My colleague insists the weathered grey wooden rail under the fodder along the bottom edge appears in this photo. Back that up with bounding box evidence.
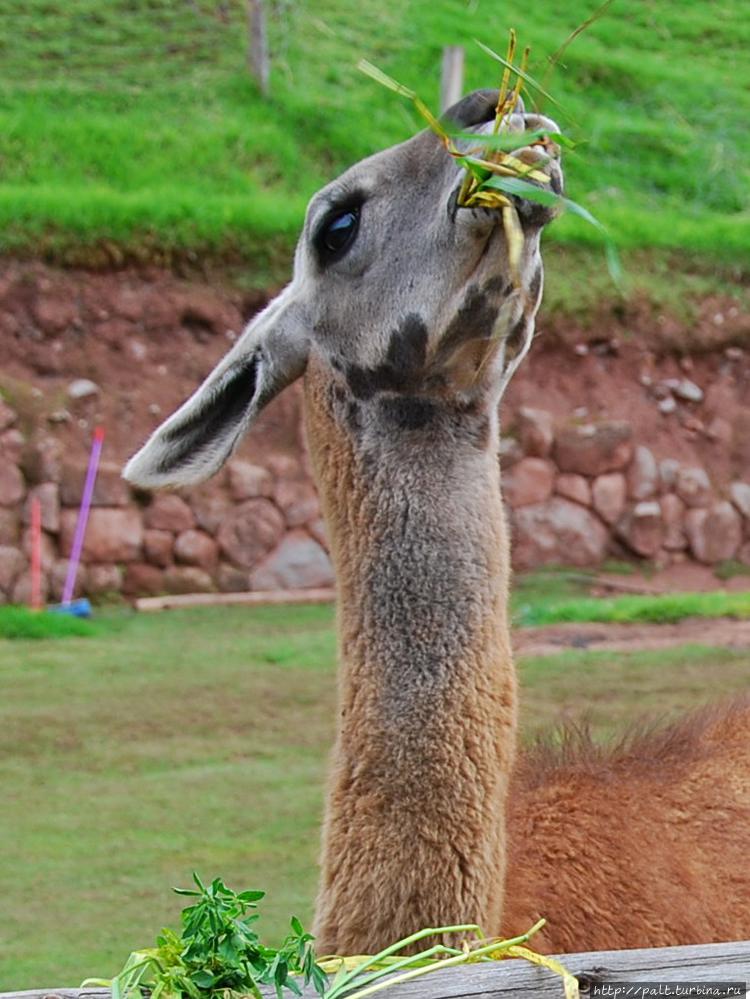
[8,940,750,999]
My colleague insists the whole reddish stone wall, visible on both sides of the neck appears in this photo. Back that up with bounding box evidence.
[0,402,750,603]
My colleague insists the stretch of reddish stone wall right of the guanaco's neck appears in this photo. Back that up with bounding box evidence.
[501,407,750,569]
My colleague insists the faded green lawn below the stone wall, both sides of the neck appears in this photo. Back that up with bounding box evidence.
[0,607,750,990]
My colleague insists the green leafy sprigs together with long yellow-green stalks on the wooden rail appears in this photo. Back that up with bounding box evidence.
[81,873,578,999]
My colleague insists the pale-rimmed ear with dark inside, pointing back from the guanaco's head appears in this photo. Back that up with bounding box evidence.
[123,285,308,489]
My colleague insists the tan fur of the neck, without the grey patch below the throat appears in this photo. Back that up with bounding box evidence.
[306,360,515,953]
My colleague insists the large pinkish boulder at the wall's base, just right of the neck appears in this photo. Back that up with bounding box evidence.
[511,496,607,569]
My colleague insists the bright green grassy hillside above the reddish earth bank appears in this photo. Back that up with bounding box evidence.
[0,0,750,276]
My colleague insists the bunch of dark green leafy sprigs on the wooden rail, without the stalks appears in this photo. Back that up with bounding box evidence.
[93,872,327,999]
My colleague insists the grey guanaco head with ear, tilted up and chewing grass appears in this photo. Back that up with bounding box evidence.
[124,91,562,487]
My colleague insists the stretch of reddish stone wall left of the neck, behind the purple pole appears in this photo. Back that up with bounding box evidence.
[0,402,333,603]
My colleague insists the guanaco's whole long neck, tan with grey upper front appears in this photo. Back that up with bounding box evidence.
[306,365,516,954]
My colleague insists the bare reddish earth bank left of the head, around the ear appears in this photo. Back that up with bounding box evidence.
[0,260,300,470]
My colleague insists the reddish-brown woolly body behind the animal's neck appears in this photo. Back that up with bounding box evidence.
[502,698,750,952]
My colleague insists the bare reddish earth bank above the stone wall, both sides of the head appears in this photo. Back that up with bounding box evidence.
[0,260,750,482]
